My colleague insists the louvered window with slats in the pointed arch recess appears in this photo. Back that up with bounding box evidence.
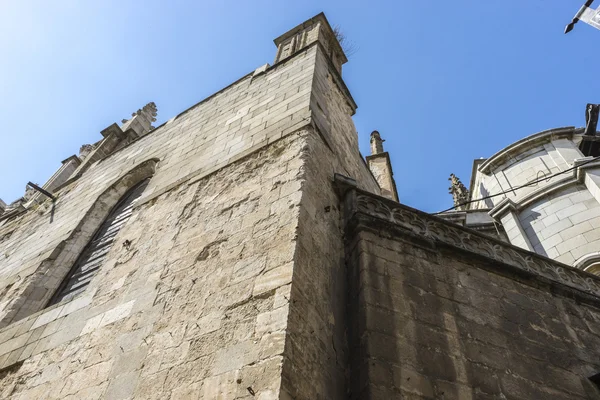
[48,179,150,306]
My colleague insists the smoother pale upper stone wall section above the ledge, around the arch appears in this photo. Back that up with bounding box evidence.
[0,46,316,327]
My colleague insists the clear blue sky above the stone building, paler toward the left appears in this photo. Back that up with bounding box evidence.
[0,0,600,212]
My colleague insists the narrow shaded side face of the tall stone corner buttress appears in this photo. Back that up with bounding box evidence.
[282,44,379,399]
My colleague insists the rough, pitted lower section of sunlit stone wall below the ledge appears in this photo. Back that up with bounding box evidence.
[0,132,306,399]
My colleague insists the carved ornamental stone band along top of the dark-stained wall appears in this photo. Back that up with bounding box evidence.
[346,190,600,296]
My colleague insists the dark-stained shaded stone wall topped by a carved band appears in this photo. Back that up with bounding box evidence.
[346,189,600,400]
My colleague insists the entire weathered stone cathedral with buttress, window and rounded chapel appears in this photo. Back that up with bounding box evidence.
[0,14,600,400]
